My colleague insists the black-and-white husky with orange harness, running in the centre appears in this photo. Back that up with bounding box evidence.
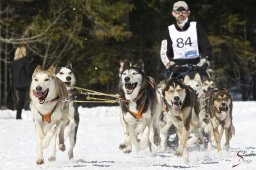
[119,60,161,153]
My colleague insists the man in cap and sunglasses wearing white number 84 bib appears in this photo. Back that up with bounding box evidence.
[160,1,212,79]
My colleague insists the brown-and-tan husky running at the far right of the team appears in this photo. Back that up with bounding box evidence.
[206,88,235,151]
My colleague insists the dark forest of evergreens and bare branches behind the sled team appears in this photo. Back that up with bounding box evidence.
[0,0,256,108]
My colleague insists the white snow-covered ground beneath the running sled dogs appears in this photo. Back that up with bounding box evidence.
[0,101,256,170]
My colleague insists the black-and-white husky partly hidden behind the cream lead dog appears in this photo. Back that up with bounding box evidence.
[55,64,80,159]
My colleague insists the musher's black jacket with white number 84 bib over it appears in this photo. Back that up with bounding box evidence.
[160,20,212,66]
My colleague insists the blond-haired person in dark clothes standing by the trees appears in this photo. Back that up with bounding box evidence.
[12,46,32,119]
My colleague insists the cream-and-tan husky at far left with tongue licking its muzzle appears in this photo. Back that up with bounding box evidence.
[30,66,69,165]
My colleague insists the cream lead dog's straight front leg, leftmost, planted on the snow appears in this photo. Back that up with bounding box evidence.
[35,121,44,165]
